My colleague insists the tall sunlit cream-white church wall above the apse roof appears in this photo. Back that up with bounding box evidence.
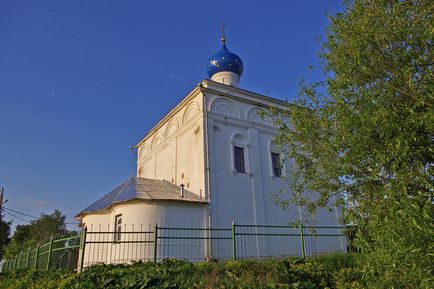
[137,93,205,197]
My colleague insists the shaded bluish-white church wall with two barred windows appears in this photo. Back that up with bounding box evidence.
[206,89,346,258]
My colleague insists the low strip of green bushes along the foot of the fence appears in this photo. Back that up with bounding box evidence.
[0,254,356,289]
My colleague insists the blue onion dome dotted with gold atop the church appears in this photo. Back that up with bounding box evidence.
[206,42,244,78]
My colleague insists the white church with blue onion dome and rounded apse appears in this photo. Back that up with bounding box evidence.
[76,35,346,259]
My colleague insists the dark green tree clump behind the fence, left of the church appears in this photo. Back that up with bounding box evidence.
[6,209,66,258]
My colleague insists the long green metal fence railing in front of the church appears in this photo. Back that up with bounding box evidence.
[3,223,350,272]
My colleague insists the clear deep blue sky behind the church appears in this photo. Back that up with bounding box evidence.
[0,0,342,228]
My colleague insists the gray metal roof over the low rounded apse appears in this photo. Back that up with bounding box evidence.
[76,177,206,217]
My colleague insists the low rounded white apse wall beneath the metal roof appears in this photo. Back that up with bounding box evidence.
[83,201,207,266]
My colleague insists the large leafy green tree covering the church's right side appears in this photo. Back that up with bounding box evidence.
[273,0,434,288]
